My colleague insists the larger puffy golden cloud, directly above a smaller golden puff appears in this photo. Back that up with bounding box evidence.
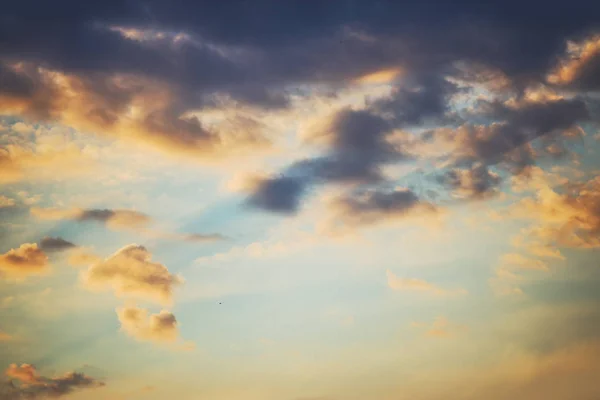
[83,244,182,304]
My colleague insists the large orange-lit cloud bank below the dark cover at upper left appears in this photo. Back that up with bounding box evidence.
[0,62,269,159]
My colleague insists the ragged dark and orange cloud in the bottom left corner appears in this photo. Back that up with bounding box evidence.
[0,364,105,400]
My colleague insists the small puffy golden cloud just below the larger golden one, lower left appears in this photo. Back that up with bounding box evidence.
[117,307,179,343]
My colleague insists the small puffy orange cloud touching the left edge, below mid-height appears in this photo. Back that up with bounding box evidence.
[0,243,49,279]
